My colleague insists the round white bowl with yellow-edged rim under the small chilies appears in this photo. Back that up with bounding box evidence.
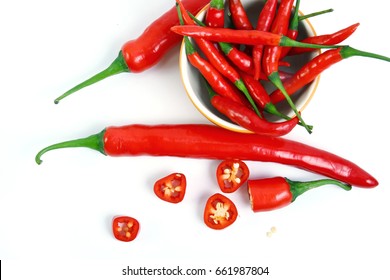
[179,0,320,133]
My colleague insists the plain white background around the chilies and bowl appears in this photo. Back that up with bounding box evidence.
[0,0,390,279]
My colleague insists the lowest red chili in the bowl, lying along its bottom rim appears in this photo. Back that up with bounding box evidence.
[206,79,298,137]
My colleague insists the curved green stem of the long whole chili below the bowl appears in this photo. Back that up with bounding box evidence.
[35,130,106,164]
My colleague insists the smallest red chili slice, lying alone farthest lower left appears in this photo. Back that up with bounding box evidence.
[112,216,139,242]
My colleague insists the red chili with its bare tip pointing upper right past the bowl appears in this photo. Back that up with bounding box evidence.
[288,23,359,55]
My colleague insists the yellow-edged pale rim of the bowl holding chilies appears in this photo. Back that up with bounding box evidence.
[179,4,322,133]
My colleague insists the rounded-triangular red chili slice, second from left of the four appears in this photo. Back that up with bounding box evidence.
[153,173,187,203]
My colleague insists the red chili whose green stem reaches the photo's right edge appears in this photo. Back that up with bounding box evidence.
[270,46,390,104]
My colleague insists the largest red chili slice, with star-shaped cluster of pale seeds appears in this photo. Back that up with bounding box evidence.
[203,193,238,230]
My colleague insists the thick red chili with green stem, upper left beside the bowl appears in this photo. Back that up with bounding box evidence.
[54,0,209,103]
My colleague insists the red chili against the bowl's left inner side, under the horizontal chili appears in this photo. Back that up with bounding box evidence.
[184,37,250,106]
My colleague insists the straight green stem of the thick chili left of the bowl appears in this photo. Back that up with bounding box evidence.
[54,51,130,104]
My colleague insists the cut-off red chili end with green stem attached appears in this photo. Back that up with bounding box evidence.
[247,177,351,212]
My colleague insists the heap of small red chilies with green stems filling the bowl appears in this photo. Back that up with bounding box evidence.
[171,0,390,136]
